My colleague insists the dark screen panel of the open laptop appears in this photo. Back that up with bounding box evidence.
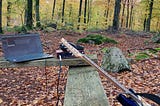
[2,34,43,57]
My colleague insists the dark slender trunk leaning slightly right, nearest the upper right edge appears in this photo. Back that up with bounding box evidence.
[146,0,154,32]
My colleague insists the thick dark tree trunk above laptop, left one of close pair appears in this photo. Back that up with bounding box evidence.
[26,0,33,29]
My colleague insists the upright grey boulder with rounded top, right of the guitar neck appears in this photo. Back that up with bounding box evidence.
[102,47,130,72]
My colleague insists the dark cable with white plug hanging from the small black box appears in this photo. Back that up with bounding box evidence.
[56,55,62,106]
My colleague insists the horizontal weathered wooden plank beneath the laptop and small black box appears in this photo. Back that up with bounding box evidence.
[0,55,97,68]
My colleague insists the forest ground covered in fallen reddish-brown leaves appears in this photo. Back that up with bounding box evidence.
[0,31,160,106]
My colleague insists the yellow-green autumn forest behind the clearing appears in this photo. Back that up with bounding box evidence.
[1,0,160,32]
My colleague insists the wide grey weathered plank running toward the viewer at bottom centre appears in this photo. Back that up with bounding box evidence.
[64,66,109,106]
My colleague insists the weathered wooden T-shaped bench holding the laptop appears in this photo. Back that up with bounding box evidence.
[0,55,109,106]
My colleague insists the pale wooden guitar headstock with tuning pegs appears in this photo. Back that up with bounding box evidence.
[61,38,82,57]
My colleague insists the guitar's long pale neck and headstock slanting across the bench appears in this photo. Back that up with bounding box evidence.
[61,38,151,106]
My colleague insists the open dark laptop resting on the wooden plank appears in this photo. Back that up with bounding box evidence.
[1,34,53,62]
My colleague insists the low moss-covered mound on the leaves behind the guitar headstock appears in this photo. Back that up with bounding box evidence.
[78,34,117,45]
